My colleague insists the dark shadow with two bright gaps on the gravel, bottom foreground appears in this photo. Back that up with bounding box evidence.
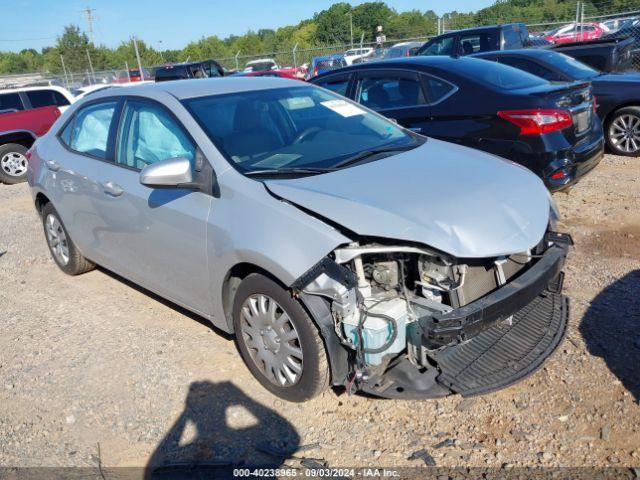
[144,381,300,480]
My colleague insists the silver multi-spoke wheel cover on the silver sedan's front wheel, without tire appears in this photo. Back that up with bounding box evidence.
[240,294,303,387]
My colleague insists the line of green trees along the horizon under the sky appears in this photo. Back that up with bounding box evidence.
[0,0,640,74]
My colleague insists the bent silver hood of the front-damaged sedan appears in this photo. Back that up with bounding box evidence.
[264,139,550,258]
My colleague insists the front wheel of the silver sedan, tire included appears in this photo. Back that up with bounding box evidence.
[233,274,329,402]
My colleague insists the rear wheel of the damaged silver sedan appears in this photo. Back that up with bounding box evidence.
[42,203,95,275]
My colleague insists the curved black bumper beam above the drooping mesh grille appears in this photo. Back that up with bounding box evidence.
[424,237,571,348]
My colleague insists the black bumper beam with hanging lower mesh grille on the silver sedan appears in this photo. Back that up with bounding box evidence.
[362,233,572,398]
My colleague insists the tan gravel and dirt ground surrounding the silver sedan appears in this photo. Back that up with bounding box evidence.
[0,156,640,467]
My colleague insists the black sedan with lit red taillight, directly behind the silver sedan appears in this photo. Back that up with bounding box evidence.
[310,56,604,190]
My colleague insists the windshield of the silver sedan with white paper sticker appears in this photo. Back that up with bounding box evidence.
[184,86,421,174]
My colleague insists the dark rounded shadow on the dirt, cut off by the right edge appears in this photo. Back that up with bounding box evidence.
[579,270,640,402]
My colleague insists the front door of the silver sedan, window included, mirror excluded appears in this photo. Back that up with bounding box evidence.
[90,99,213,314]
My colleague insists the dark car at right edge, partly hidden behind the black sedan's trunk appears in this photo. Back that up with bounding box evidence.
[474,49,640,157]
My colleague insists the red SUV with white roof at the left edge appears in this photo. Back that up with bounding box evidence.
[0,86,74,183]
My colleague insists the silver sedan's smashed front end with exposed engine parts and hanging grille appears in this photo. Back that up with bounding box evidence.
[292,231,572,398]
